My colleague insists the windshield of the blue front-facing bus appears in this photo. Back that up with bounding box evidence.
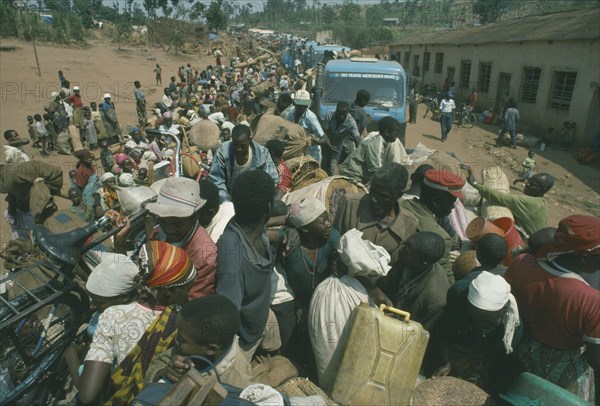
[323,72,405,108]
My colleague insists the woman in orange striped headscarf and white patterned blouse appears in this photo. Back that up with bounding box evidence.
[73,239,196,405]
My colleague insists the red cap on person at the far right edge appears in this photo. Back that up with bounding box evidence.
[537,214,600,259]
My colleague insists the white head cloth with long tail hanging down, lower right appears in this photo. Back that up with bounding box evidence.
[467,271,520,354]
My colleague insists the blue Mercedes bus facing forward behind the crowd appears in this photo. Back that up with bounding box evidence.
[313,58,408,142]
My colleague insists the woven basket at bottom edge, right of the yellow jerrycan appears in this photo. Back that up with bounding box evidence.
[410,376,495,406]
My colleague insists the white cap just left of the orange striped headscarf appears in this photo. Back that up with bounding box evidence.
[85,252,139,297]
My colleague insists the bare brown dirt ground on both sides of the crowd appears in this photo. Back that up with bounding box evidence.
[0,39,600,247]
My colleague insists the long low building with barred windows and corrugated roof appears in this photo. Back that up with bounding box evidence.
[390,7,600,145]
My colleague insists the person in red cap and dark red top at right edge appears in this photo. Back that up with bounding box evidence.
[505,214,600,403]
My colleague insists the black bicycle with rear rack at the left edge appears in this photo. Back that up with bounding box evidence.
[0,210,146,404]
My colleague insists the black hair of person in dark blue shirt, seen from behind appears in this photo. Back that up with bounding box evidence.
[231,169,275,225]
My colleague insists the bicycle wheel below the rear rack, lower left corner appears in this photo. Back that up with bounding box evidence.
[0,294,83,404]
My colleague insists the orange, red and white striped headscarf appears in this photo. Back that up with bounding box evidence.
[139,241,196,288]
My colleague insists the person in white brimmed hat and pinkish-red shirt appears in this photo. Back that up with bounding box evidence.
[146,178,217,299]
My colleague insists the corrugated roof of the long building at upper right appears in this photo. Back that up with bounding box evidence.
[392,7,600,45]
